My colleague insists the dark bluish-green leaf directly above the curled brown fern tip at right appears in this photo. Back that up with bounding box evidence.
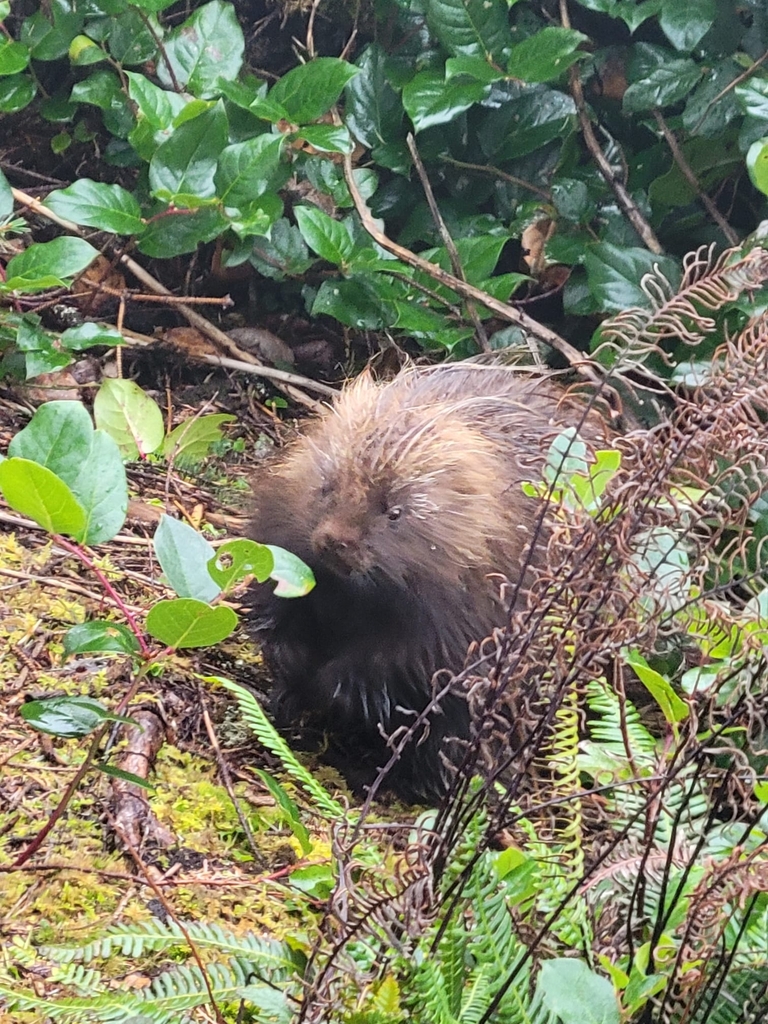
[584,242,680,311]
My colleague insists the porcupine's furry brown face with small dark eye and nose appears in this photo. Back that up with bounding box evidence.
[294,391,502,589]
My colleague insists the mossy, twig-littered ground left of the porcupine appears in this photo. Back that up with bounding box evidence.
[0,371,372,1011]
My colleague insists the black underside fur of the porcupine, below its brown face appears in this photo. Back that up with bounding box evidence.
[252,572,487,803]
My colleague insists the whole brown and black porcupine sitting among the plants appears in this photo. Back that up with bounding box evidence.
[250,364,593,802]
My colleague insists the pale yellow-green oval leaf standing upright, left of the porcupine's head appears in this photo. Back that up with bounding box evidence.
[93,379,165,460]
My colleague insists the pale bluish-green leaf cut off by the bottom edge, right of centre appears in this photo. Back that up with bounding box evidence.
[531,957,621,1024]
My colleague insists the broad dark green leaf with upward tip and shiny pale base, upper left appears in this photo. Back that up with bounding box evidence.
[150,100,227,206]
